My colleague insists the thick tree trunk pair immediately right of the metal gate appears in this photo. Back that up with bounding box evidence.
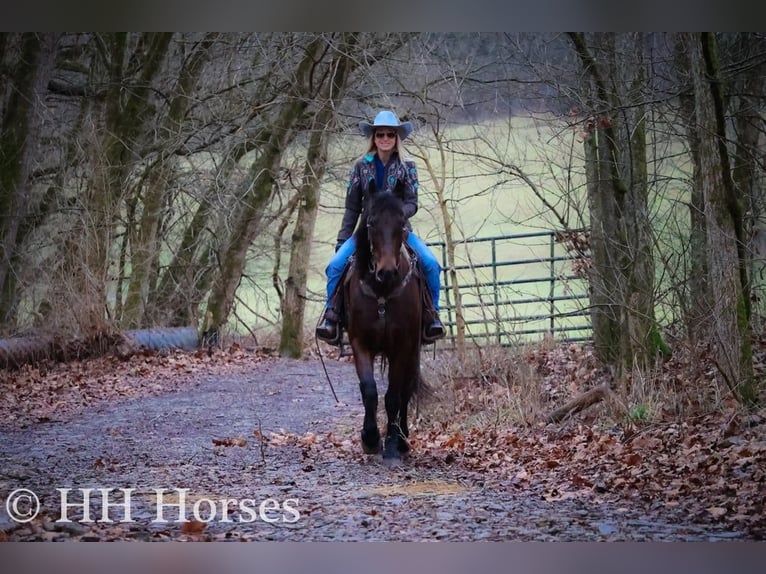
[570,30,667,382]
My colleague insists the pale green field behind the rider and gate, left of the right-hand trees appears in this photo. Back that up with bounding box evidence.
[237,118,585,339]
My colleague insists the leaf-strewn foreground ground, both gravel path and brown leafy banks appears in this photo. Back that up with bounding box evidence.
[0,347,766,541]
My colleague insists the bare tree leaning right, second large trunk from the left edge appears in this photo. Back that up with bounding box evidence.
[65,33,172,330]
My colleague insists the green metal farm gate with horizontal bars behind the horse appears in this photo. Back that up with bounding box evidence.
[429,231,591,348]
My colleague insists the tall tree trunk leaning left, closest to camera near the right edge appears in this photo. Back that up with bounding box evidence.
[689,33,756,403]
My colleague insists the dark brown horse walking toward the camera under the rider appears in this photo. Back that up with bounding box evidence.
[344,182,424,459]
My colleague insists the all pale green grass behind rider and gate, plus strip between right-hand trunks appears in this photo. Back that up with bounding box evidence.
[231,113,766,341]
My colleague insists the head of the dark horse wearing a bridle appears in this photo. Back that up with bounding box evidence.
[365,183,408,289]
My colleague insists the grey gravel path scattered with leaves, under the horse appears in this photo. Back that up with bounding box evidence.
[0,360,744,541]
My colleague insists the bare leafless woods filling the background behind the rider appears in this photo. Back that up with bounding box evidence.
[0,33,766,402]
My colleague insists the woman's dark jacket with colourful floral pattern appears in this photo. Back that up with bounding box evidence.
[335,152,418,251]
